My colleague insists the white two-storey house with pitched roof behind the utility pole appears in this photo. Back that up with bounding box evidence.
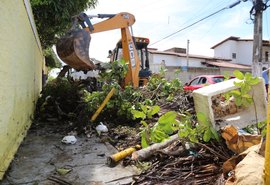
[211,36,270,67]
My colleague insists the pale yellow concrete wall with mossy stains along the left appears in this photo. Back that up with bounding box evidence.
[0,0,44,180]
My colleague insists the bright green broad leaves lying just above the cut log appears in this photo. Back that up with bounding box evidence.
[132,106,220,148]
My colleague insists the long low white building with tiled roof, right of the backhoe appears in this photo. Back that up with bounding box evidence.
[148,47,251,83]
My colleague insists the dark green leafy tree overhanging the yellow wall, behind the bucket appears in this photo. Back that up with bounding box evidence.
[30,0,98,68]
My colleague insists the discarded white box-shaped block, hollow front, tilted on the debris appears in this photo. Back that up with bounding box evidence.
[193,78,267,129]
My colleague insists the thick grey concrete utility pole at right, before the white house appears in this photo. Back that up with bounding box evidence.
[252,0,264,76]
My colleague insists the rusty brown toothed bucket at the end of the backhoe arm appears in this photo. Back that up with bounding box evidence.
[56,29,95,71]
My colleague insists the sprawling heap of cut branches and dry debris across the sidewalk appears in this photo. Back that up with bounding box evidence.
[36,67,266,185]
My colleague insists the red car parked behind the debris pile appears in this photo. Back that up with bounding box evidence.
[184,75,235,91]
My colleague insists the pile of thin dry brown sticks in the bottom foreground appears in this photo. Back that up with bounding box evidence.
[134,141,231,185]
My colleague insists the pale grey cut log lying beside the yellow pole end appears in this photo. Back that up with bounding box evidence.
[132,134,179,161]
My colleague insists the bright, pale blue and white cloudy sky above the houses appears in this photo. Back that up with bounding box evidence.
[83,0,270,62]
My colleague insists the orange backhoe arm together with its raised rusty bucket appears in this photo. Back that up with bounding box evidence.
[56,12,141,88]
